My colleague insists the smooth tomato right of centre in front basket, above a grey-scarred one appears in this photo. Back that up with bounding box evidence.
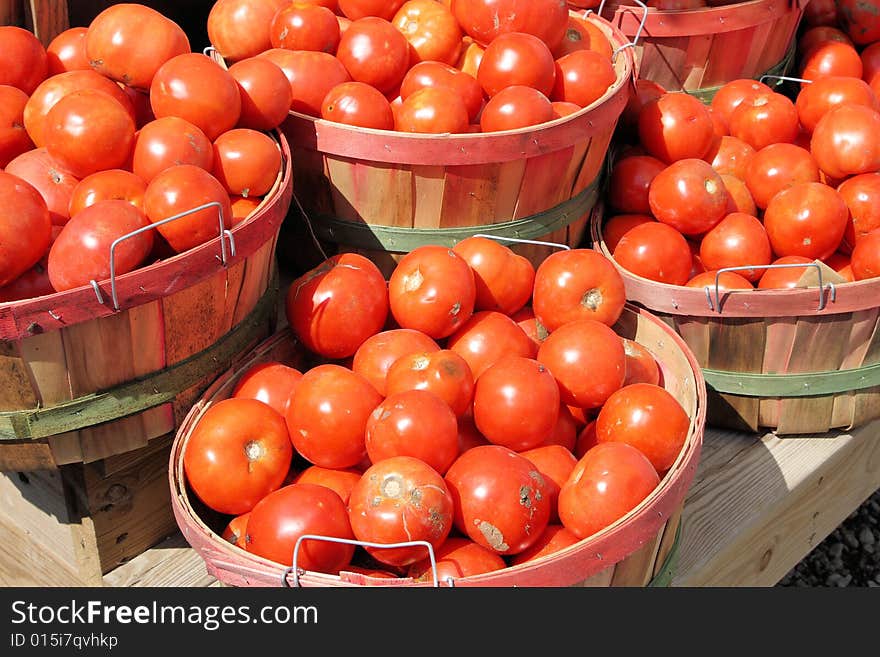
[474,356,560,452]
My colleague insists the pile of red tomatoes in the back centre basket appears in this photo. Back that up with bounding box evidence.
[207,0,617,134]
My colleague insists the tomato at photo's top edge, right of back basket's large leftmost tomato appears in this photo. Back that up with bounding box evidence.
[269,3,340,55]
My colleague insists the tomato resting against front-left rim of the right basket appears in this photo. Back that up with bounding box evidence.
[613,221,693,285]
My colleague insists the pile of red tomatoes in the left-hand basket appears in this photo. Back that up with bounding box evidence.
[0,3,289,302]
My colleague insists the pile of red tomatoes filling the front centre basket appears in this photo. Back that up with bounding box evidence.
[183,237,691,580]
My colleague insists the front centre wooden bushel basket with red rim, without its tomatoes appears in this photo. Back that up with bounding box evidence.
[169,306,706,586]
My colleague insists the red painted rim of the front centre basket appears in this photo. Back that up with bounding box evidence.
[168,304,707,586]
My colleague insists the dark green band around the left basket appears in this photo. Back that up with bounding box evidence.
[0,273,278,441]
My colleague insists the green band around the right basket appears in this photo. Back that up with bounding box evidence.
[703,363,880,397]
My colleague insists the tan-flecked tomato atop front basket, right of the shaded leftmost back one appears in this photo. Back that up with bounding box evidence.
[388,245,477,340]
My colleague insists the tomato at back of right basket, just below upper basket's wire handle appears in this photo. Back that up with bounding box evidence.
[728,92,800,151]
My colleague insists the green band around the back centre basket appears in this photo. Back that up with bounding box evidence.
[311,176,601,253]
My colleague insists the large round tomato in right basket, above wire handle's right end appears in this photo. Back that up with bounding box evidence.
[764,182,849,260]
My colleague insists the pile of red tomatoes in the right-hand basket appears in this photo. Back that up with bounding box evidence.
[603,2,880,290]
